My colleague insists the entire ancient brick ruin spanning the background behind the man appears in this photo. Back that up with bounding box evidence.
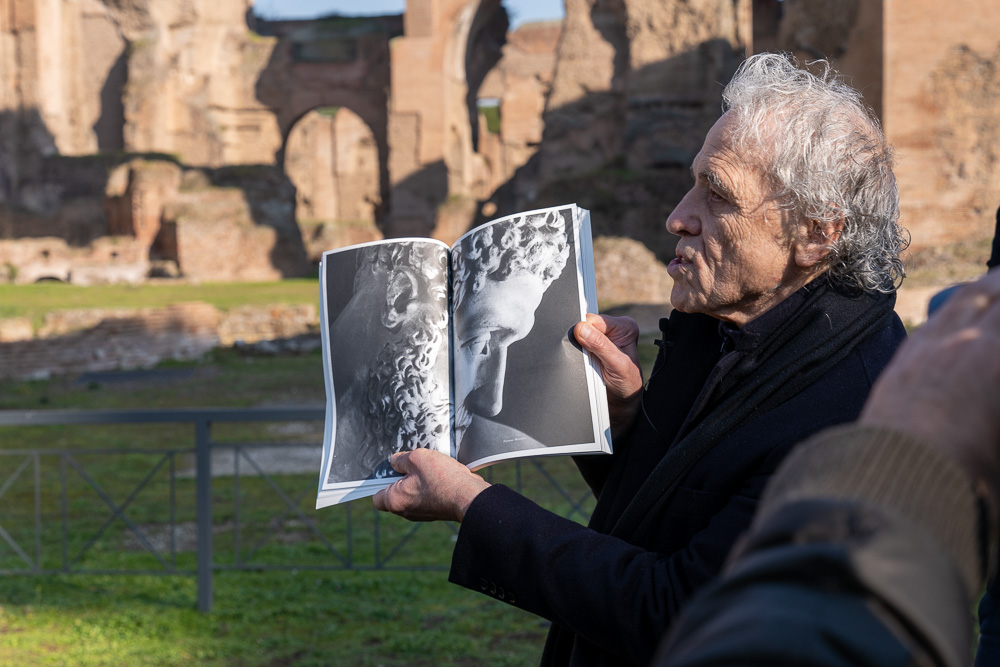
[0,0,1000,378]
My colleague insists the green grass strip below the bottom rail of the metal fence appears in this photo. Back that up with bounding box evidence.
[0,572,546,666]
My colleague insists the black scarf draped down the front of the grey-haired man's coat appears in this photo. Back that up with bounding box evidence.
[611,284,896,544]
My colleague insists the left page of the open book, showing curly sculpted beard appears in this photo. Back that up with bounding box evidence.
[316,239,451,508]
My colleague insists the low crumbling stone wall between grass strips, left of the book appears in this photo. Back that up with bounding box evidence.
[0,302,319,380]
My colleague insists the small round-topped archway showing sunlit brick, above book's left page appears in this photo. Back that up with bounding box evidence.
[283,107,383,261]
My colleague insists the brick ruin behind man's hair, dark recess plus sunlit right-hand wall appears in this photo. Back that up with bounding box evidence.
[754,0,1000,251]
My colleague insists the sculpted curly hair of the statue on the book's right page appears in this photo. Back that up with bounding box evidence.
[452,211,569,309]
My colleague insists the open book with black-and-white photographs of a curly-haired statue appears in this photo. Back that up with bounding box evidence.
[316,205,611,509]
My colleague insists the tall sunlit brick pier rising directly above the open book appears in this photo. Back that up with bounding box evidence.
[386,0,507,242]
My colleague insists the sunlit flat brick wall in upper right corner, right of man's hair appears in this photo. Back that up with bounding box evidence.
[883,0,1000,248]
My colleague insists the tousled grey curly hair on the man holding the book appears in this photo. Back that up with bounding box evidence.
[722,53,909,293]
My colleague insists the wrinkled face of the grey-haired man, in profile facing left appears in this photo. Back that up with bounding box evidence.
[667,114,797,326]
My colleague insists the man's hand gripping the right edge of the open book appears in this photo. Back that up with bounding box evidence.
[573,313,642,438]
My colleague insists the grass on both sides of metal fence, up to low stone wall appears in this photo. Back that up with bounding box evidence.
[0,342,589,666]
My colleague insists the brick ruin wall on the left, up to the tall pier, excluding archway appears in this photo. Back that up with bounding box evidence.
[0,0,394,284]
